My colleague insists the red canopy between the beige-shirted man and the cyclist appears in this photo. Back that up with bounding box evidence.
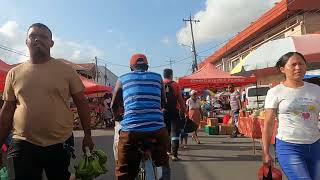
[80,76,112,95]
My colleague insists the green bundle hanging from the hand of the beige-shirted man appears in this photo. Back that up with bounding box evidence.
[74,150,108,180]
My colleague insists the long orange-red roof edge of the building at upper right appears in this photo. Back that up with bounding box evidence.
[200,0,320,67]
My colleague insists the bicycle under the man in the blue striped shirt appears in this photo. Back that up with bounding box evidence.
[135,139,162,180]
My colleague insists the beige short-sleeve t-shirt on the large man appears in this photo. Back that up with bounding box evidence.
[3,58,84,147]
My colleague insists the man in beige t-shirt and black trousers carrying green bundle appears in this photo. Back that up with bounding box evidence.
[0,23,94,180]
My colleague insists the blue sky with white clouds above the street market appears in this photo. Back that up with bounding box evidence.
[0,0,275,76]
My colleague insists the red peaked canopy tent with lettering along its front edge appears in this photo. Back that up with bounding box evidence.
[178,63,256,89]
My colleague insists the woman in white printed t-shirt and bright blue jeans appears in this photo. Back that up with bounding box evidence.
[262,52,320,180]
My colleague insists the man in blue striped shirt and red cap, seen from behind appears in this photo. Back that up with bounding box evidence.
[111,54,170,180]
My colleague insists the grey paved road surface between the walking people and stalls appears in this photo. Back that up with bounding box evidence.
[71,130,286,180]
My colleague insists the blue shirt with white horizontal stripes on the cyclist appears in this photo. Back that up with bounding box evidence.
[119,71,165,132]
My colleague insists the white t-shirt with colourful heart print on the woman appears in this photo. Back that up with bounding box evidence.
[265,82,320,144]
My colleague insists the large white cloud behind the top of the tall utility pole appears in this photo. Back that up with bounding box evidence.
[177,0,279,44]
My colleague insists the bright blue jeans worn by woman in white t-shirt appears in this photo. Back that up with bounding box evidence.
[276,139,320,180]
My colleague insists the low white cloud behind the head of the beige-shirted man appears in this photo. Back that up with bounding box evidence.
[0,21,105,64]
